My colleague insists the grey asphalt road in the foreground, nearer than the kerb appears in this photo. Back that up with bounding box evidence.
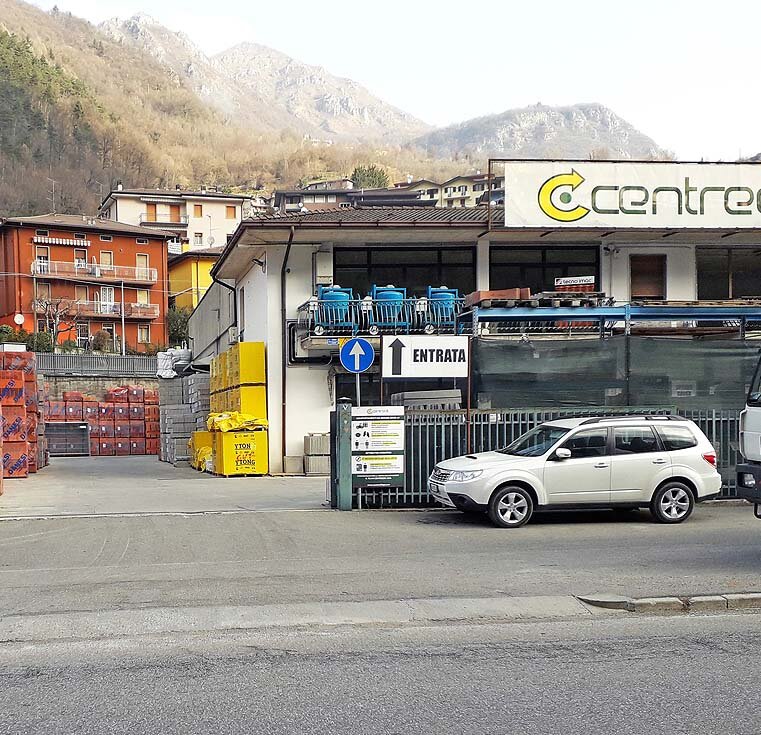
[0,615,761,735]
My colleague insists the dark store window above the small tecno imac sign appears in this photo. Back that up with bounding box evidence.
[489,246,600,293]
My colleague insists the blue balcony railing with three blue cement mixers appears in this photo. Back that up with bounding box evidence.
[297,297,464,338]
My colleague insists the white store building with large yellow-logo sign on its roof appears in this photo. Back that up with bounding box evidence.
[198,161,761,471]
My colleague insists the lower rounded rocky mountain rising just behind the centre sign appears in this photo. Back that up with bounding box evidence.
[410,104,667,159]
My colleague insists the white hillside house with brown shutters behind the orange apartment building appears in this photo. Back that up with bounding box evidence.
[99,184,267,252]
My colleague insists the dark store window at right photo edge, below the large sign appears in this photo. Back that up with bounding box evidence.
[695,248,761,301]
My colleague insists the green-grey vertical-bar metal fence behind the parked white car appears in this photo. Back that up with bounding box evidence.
[355,406,740,508]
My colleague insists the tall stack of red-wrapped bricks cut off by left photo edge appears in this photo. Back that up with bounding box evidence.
[0,352,48,486]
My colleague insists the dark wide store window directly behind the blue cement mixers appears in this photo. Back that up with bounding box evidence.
[333,247,476,298]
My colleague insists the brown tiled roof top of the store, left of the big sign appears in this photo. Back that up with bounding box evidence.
[241,207,504,227]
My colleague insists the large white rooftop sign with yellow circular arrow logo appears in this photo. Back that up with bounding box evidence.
[505,161,761,229]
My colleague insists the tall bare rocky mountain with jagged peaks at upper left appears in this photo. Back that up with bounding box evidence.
[99,14,431,143]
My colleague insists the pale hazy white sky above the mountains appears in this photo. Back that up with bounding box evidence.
[36,0,761,160]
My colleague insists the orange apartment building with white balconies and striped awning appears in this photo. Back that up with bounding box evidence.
[0,214,174,351]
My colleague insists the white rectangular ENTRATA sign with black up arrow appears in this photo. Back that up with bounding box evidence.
[381,335,469,378]
